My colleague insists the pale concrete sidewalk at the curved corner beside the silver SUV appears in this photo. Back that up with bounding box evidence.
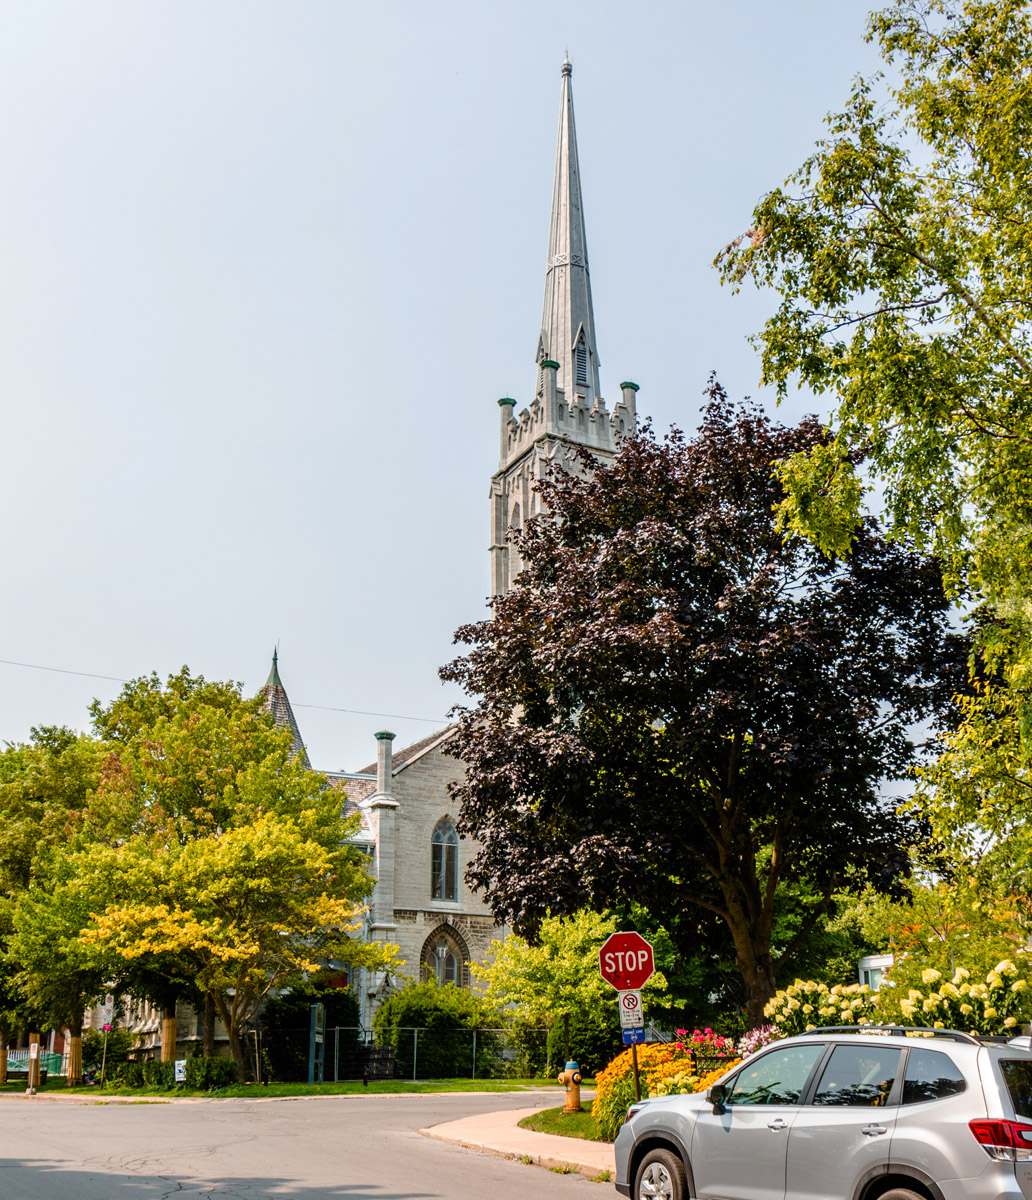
[419,1106,616,1178]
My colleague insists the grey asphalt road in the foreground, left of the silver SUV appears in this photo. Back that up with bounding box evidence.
[0,1093,604,1200]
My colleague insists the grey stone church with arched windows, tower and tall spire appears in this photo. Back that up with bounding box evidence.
[96,61,638,1049]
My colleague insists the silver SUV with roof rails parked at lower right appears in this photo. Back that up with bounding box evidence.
[616,1026,1032,1200]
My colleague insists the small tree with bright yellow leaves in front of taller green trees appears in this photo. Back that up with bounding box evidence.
[72,812,396,1070]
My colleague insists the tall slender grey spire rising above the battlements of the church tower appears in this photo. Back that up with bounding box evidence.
[536,59,600,407]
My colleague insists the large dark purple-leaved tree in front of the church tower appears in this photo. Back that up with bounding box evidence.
[442,385,966,1025]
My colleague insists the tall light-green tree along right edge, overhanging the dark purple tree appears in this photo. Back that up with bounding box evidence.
[721,0,1032,887]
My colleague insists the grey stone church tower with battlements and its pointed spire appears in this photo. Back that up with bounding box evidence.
[491,61,638,596]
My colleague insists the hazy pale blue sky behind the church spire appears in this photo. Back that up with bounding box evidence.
[0,0,875,769]
